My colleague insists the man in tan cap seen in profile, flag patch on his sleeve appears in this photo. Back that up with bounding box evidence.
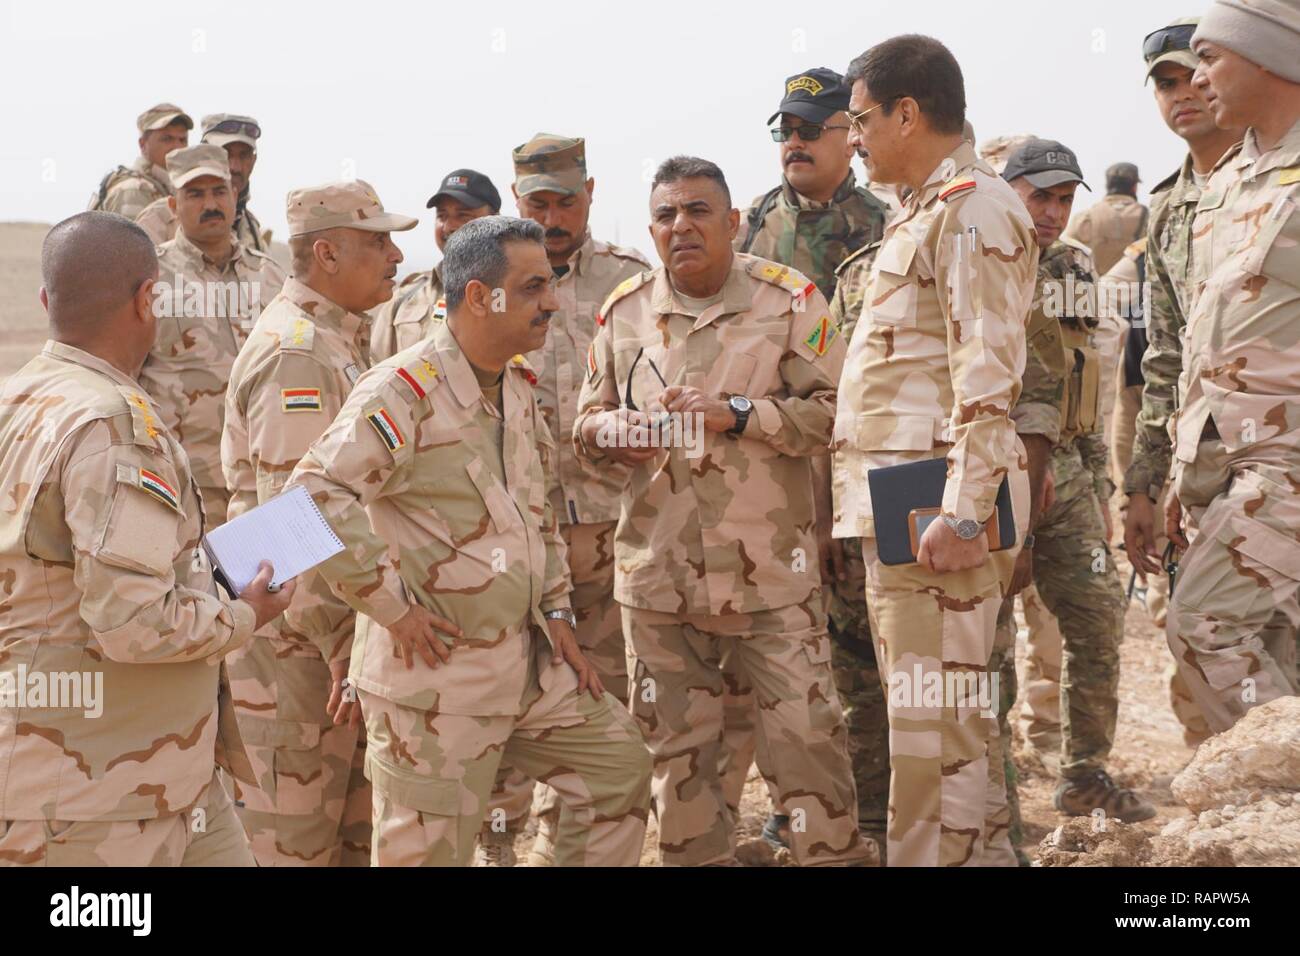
[221,179,416,866]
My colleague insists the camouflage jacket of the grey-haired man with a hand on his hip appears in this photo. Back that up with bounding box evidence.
[291,323,571,715]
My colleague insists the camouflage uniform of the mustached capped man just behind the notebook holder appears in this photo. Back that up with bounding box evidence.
[140,233,285,529]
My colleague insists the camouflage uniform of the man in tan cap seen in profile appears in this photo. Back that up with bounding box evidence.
[221,278,371,866]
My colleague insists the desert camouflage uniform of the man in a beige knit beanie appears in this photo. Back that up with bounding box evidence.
[1167,124,1300,732]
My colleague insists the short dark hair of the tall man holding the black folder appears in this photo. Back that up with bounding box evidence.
[844,34,966,133]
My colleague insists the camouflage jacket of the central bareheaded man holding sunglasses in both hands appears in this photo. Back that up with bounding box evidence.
[573,252,844,615]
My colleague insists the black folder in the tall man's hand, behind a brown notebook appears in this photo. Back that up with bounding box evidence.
[867,458,1015,564]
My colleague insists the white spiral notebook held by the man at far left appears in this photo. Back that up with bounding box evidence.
[203,485,343,596]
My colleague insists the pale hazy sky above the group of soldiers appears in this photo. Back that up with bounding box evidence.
[0,0,1209,271]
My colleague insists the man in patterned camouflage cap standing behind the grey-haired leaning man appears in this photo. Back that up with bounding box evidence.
[478,133,650,866]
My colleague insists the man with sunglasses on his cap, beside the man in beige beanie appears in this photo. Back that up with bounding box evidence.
[1115,17,1248,748]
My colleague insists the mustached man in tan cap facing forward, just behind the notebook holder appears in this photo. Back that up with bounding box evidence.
[140,143,285,528]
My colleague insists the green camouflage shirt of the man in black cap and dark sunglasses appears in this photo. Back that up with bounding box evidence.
[733,169,889,299]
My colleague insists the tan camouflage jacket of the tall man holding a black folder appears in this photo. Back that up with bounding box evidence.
[832,143,1039,537]
